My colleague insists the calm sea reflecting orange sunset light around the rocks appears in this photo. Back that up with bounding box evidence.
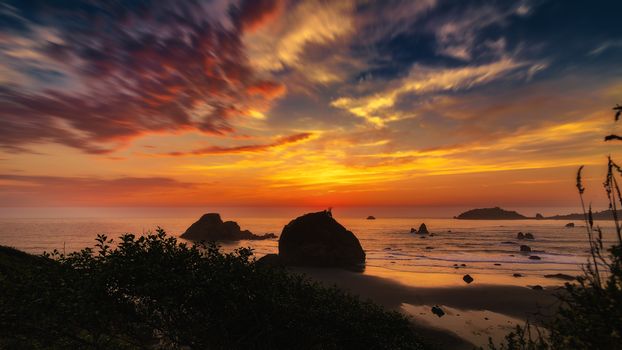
[0,215,613,286]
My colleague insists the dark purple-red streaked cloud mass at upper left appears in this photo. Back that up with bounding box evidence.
[0,1,284,154]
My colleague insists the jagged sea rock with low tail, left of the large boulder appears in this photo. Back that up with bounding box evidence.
[181,213,276,241]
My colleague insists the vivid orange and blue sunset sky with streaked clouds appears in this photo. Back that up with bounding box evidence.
[0,0,622,212]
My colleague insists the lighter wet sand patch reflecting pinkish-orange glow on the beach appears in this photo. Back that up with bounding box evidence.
[402,304,525,346]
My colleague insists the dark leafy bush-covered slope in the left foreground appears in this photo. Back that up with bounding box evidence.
[0,230,428,349]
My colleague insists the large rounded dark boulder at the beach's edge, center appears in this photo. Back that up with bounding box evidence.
[279,211,365,270]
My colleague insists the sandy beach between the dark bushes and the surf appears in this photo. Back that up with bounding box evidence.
[292,268,558,349]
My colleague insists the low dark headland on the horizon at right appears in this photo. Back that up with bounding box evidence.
[454,207,622,220]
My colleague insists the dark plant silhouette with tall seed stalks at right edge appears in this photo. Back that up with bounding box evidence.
[488,105,622,350]
